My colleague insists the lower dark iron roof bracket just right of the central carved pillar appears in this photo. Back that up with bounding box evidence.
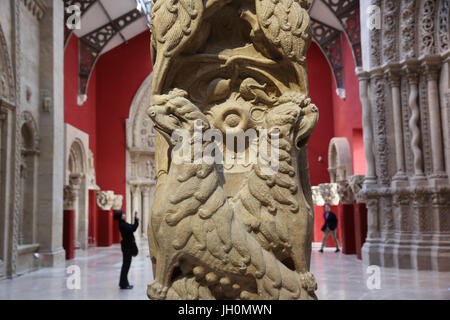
[311,18,345,97]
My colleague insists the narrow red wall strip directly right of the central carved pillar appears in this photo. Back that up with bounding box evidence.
[307,43,334,186]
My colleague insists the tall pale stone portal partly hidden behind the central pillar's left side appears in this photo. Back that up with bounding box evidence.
[126,74,156,237]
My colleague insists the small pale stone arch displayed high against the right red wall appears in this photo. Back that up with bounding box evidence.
[328,138,353,183]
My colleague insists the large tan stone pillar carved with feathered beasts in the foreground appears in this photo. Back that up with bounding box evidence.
[147,0,318,299]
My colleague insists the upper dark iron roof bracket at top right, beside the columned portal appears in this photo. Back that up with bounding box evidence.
[321,0,362,67]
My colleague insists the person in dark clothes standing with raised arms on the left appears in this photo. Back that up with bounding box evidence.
[114,210,139,289]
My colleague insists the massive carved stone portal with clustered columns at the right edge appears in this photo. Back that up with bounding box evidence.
[358,0,450,271]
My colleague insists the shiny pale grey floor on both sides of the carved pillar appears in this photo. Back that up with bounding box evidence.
[0,241,450,300]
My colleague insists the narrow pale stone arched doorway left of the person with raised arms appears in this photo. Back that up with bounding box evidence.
[64,124,89,249]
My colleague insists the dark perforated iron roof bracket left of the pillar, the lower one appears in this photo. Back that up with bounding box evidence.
[78,9,142,100]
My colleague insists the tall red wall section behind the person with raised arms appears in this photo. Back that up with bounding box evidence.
[96,32,152,218]
